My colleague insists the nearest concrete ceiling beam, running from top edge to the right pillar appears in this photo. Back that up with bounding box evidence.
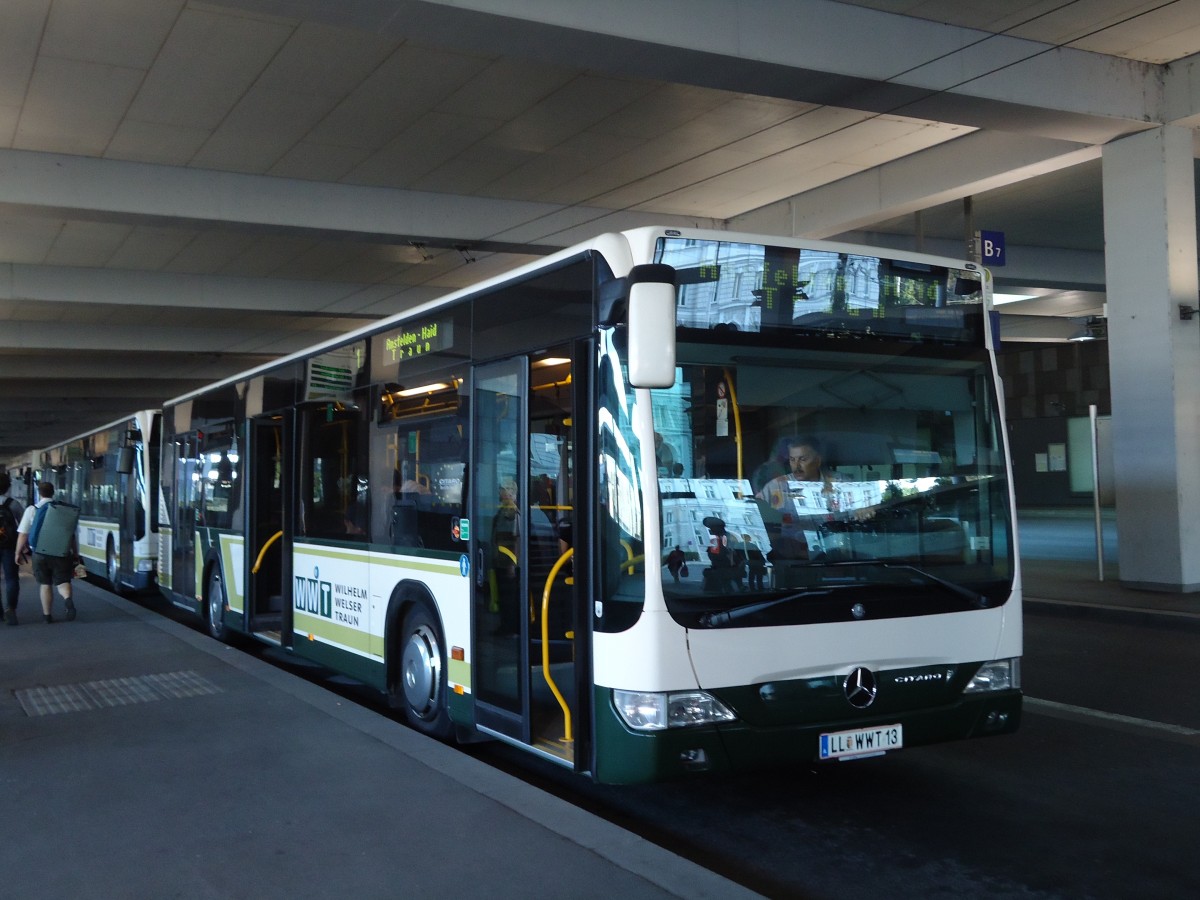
[231,0,1163,143]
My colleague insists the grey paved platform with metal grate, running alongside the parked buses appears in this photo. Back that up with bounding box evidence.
[0,578,756,900]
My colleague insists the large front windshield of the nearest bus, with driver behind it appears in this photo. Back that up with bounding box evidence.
[653,341,1013,628]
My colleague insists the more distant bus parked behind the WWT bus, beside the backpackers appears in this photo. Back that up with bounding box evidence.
[35,409,162,593]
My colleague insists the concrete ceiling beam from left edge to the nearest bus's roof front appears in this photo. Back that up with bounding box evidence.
[0,149,697,254]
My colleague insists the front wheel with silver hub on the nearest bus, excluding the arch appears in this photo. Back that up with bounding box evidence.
[392,605,454,740]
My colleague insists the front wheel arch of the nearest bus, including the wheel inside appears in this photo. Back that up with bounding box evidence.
[388,582,455,740]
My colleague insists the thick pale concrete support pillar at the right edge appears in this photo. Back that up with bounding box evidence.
[1103,126,1200,592]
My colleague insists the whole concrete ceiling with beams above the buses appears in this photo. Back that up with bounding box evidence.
[0,0,1200,462]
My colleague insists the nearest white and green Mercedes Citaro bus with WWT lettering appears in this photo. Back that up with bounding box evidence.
[160,228,1021,782]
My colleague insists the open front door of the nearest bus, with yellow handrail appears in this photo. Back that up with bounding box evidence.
[470,348,587,763]
